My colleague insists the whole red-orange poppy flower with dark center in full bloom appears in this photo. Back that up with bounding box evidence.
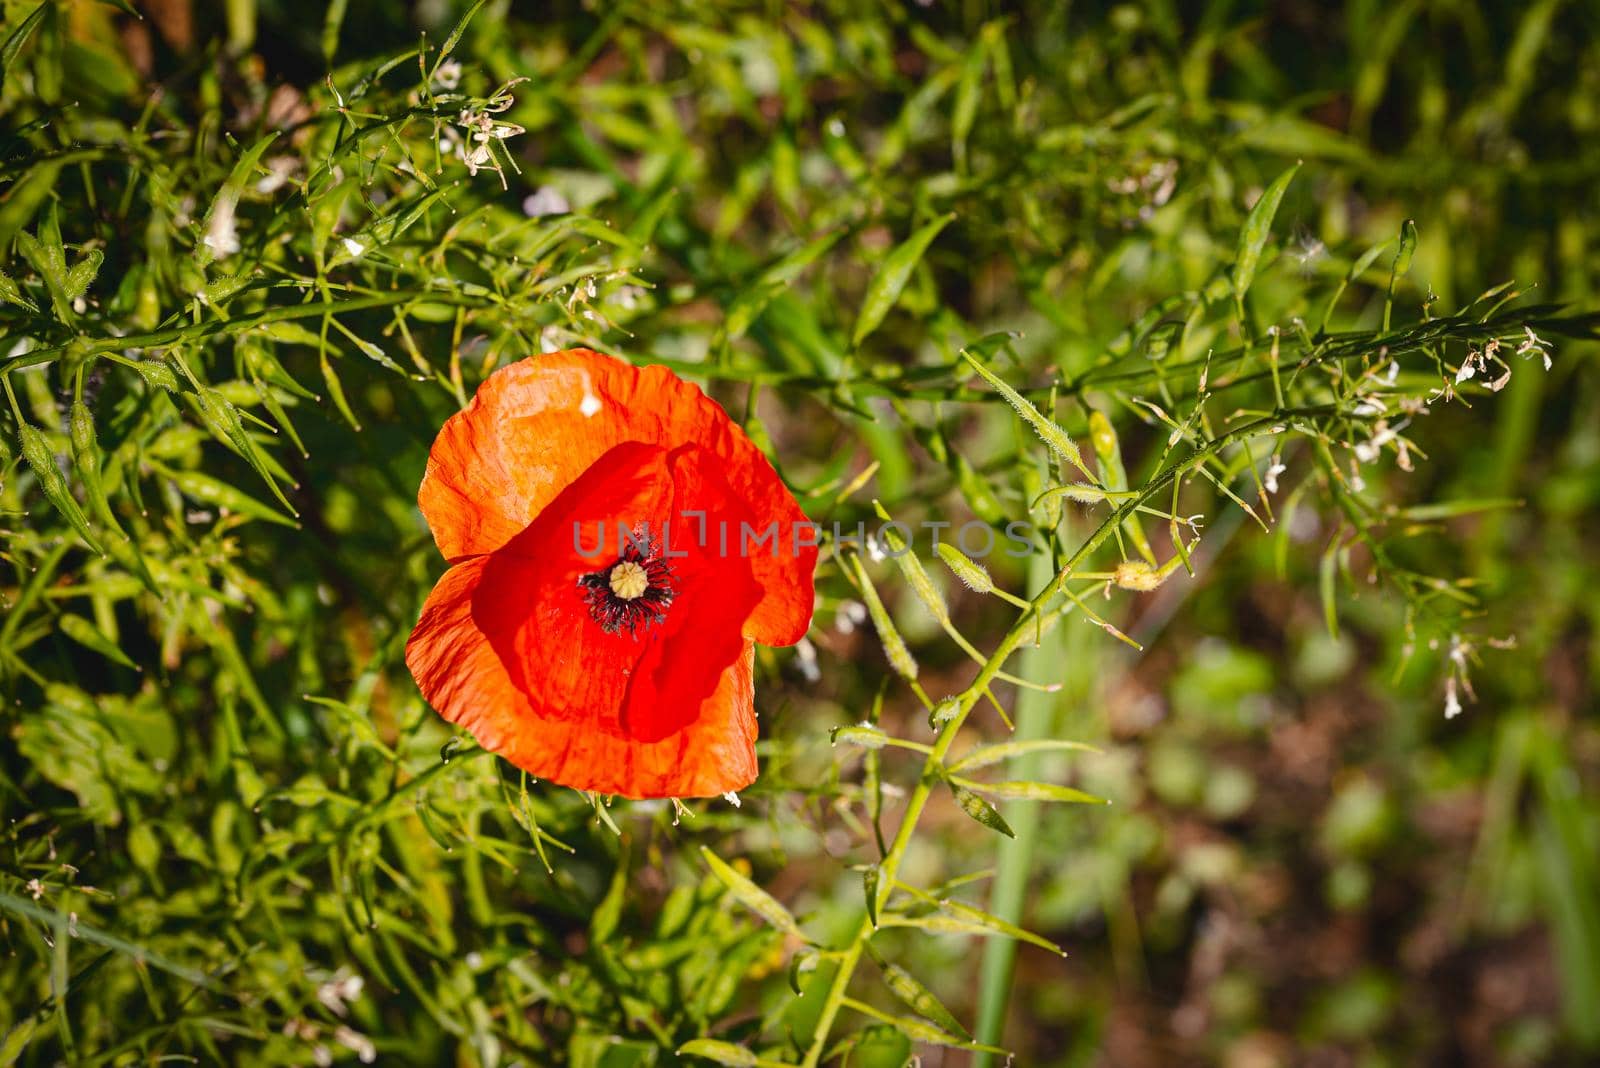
[406,349,816,798]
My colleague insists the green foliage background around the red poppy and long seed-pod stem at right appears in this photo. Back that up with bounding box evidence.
[0,0,1600,1068]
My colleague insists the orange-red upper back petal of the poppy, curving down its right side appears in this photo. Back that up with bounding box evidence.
[418,349,816,646]
